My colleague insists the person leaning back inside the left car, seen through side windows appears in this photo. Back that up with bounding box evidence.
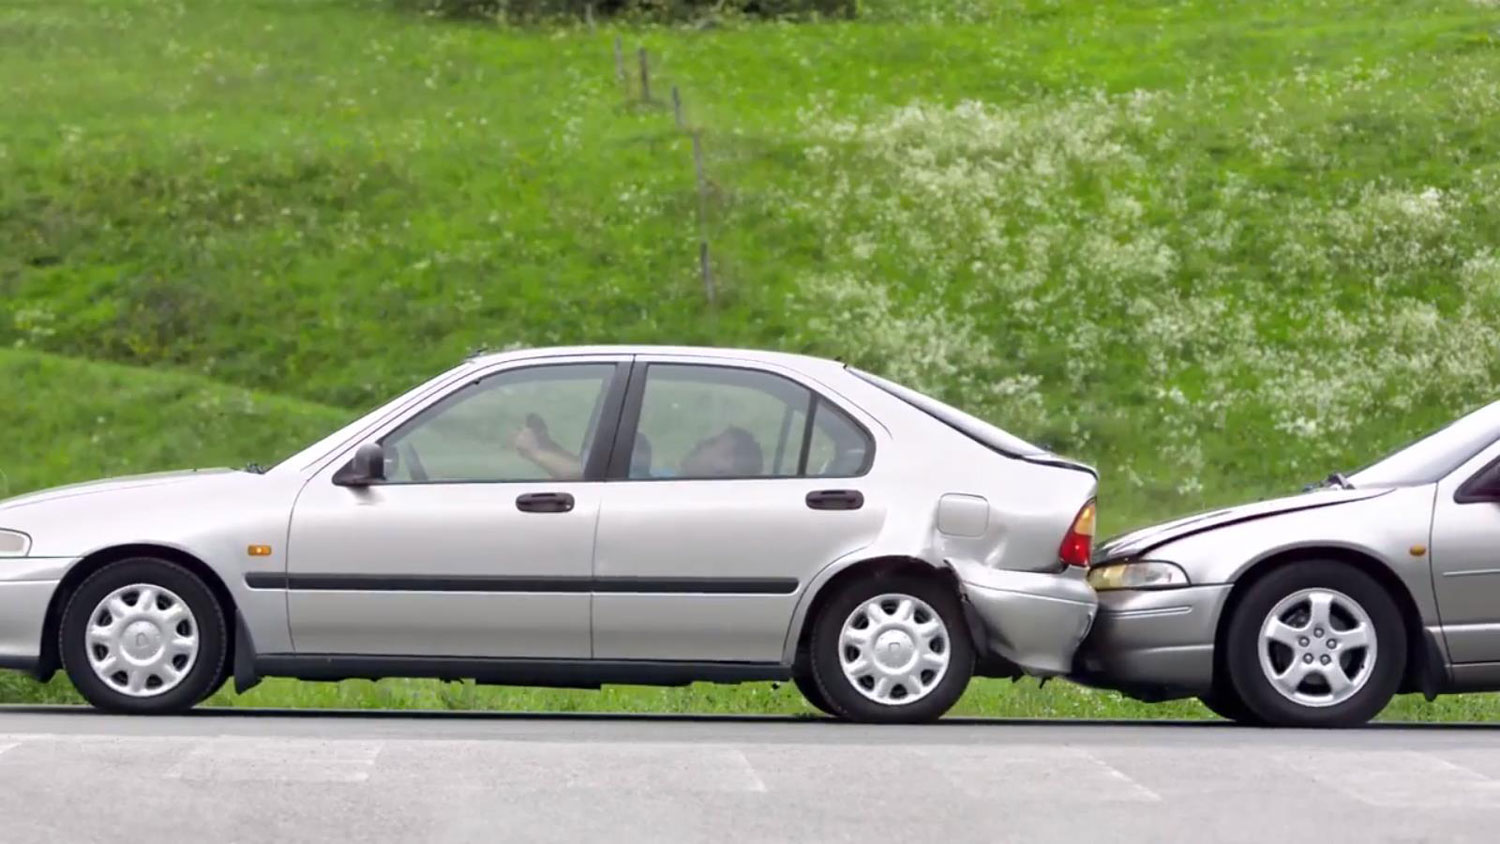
[513,414,765,480]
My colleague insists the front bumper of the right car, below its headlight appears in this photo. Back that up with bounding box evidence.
[1073,583,1233,700]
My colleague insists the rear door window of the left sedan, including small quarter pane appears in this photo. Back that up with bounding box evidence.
[630,364,872,480]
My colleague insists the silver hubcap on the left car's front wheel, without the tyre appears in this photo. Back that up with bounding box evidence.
[86,583,198,697]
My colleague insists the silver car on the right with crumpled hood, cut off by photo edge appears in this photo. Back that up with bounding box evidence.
[1079,403,1500,726]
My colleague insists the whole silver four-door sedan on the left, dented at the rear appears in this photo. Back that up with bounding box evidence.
[0,348,1097,721]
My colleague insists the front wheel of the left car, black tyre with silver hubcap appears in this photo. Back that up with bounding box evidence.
[59,558,228,714]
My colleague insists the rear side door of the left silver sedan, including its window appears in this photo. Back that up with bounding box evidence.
[594,357,885,663]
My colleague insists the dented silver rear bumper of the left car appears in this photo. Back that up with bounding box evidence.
[954,564,1098,676]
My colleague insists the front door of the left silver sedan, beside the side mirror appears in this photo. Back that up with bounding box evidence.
[285,357,629,658]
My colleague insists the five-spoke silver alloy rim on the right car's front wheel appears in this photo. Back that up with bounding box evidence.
[1260,588,1377,708]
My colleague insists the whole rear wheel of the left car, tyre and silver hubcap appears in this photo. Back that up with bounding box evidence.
[809,576,974,723]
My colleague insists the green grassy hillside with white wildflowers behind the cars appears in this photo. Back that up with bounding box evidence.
[0,0,1500,718]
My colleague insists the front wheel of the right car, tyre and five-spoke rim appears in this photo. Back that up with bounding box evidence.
[1224,561,1407,727]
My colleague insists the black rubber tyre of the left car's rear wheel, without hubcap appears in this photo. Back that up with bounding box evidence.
[809,574,974,724]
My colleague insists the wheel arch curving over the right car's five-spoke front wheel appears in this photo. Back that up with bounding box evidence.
[1214,544,1428,693]
